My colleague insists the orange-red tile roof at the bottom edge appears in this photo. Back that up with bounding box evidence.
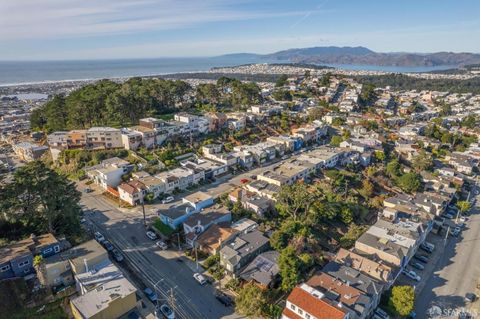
[284,287,346,319]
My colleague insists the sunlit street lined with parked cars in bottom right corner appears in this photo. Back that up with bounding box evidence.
[415,184,480,318]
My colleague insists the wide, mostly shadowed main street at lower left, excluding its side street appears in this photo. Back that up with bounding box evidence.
[81,189,244,319]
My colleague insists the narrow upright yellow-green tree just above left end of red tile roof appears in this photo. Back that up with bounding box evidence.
[278,246,302,291]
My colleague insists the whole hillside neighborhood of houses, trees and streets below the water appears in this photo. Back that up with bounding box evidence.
[0,64,480,319]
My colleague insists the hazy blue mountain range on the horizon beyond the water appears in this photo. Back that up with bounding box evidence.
[218,46,480,67]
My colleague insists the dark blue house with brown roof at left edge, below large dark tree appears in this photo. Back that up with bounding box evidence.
[0,234,61,279]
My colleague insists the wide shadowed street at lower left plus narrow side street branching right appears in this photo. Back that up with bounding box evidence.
[78,151,310,318]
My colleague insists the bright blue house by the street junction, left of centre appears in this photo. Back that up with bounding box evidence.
[158,192,214,229]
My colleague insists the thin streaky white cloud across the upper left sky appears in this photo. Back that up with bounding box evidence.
[0,0,312,40]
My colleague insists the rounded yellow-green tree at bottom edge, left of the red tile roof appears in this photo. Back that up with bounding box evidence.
[235,284,267,317]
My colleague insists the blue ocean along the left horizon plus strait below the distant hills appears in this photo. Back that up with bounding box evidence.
[0,55,458,86]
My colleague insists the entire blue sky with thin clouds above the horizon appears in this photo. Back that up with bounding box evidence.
[0,0,480,60]
